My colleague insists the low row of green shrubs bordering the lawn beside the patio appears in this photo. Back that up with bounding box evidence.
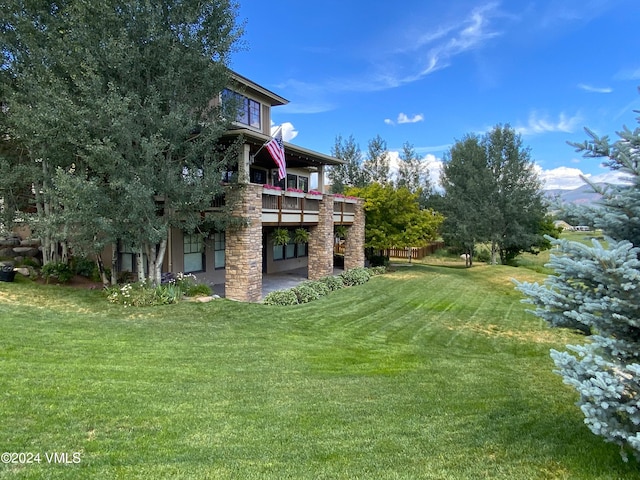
[263,267,387,305]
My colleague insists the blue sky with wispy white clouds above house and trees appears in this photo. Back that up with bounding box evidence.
[231,0,640,188]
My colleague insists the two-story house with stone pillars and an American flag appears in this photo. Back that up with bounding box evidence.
[140,73,364,302]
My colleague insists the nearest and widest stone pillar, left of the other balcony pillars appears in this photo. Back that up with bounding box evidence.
[225,184,262,302]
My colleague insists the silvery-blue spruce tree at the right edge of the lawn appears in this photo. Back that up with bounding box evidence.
[517,111,640,459]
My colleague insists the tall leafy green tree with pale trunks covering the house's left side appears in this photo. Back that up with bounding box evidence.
[0,0,240,283]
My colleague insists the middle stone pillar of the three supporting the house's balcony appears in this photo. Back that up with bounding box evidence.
[307,195,333,280]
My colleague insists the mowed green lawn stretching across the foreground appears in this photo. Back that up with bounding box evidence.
[0,264,640,480]
